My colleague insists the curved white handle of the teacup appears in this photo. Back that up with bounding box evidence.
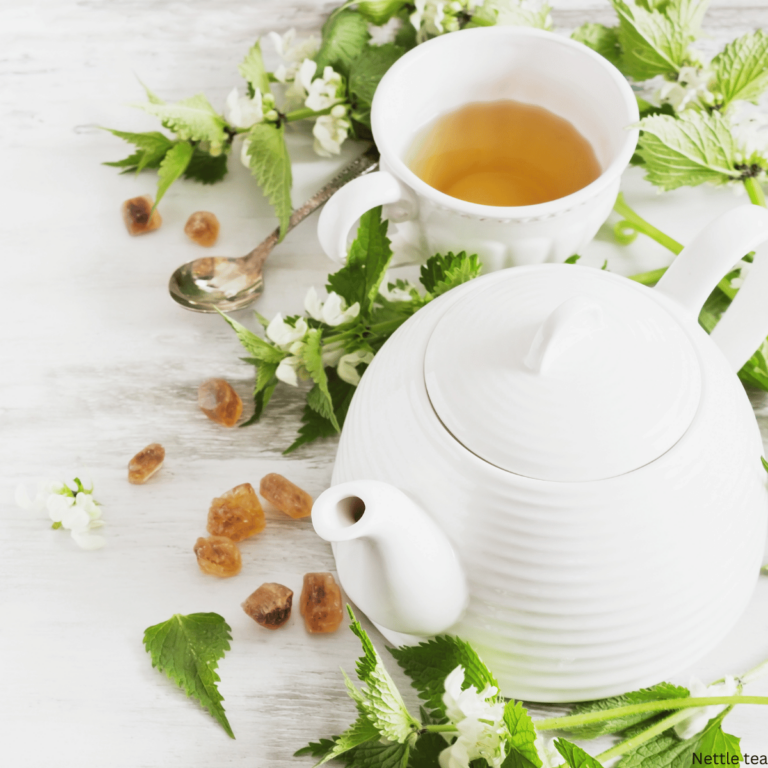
[317,171,411,264]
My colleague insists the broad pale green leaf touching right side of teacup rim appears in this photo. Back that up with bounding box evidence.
[637,110,741,190]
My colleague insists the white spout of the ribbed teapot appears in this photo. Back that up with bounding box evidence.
[312,480,468,637]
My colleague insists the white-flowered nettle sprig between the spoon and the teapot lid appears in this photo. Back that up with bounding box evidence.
[222,207,481,453]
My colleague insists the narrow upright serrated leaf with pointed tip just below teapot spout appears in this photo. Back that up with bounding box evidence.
[347,607,421,744]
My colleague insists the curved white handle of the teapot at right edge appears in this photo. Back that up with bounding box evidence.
[656,205,768,371]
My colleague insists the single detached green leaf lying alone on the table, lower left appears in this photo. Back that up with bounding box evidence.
[144,613,235,739]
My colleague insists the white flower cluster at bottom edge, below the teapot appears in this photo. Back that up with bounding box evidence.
[439,666,506,768]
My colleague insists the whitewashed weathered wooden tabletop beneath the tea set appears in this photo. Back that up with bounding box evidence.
[0,0,768,768]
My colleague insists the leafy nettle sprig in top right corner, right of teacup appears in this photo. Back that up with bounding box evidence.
[573,0,768,205]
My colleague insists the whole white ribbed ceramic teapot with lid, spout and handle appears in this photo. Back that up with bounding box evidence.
[312,205,768,702]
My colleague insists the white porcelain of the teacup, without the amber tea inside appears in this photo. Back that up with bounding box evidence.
[318,27,639,270]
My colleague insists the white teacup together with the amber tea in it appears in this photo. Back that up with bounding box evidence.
[318,27,639,271]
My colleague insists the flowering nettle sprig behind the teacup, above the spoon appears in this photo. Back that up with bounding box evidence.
[105,0,552,233]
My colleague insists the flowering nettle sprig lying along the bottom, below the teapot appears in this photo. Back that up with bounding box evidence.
[296,608,768,768]
